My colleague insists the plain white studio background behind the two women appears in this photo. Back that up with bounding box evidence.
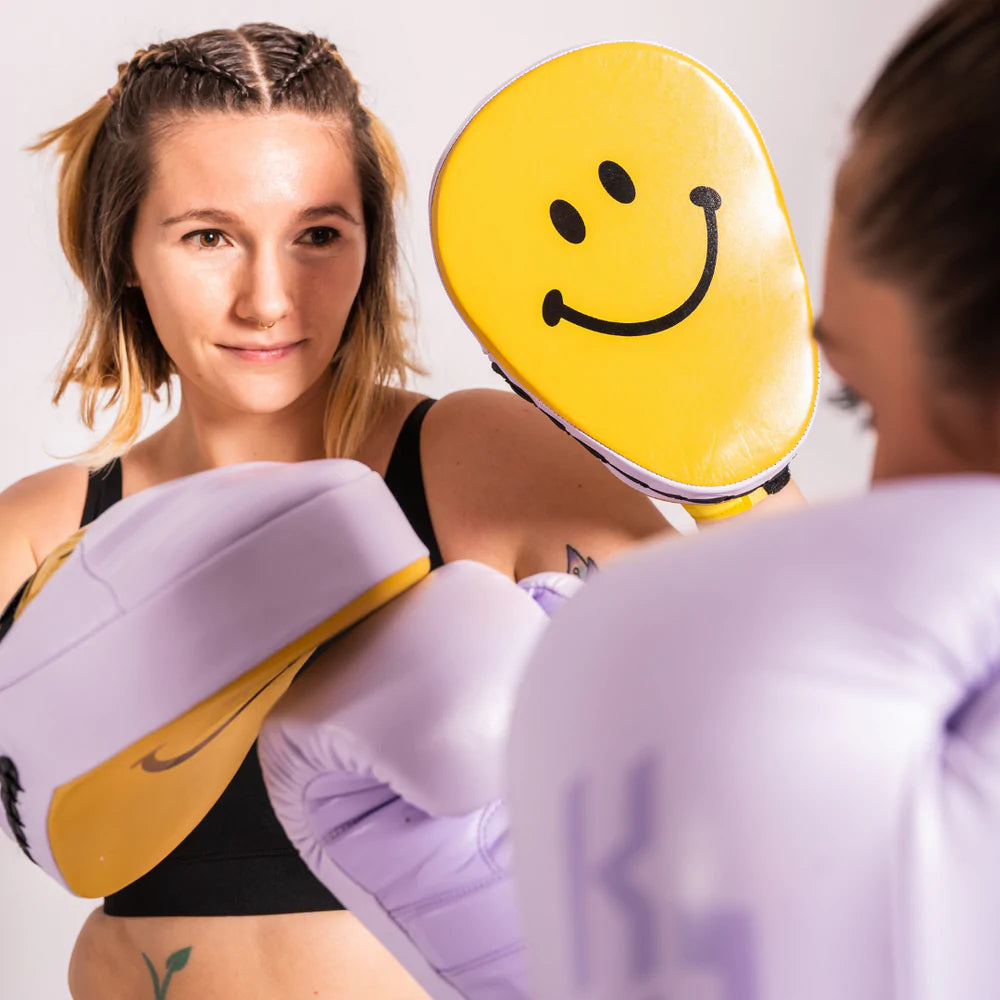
[0,0,925,1000]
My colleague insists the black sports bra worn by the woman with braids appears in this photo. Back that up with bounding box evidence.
[96,399,443,917]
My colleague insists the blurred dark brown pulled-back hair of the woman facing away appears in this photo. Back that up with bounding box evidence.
[843,0,1000,399]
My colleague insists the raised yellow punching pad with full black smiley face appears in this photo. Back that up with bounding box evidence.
[431,42,819,504]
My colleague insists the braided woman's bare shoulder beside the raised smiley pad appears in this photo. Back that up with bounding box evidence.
[421,389,670,578]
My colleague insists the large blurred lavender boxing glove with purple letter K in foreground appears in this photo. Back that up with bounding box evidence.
[509,477,1000,1000]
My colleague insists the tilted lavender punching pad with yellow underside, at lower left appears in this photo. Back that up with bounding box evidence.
[0,460,429,896]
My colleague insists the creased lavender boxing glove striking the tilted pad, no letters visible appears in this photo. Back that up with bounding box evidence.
[259,562,581,1000]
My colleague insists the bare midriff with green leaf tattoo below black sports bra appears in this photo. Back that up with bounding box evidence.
[69,909,428,1000]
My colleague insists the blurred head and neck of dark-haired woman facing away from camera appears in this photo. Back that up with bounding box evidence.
[815,0,1000,480]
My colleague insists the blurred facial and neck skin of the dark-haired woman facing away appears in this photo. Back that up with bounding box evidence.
[816,161,995,480]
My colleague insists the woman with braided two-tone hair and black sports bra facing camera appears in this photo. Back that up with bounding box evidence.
[0,24,795,1000]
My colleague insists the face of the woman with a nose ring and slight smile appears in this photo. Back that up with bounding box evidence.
[132,113,366,413]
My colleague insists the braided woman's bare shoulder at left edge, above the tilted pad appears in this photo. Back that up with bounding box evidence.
[0,464,87,604]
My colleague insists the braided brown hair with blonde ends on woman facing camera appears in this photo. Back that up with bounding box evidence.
[33,24,417,461]
